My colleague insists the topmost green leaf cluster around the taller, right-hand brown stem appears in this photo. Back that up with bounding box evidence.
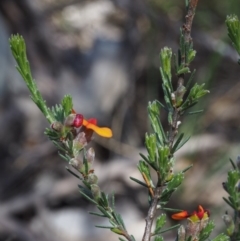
[160,47,209,116]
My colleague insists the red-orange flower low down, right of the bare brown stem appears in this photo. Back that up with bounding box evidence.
[172,205,210,222]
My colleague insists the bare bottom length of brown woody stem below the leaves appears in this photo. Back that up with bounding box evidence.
[142,187,162,241]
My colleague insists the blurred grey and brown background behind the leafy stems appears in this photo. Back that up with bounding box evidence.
[0,0,240,241]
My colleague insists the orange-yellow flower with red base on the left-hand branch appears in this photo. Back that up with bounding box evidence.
[72,109,112,138]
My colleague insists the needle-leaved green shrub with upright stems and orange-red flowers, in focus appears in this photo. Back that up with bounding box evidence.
[7,0,240,241]
